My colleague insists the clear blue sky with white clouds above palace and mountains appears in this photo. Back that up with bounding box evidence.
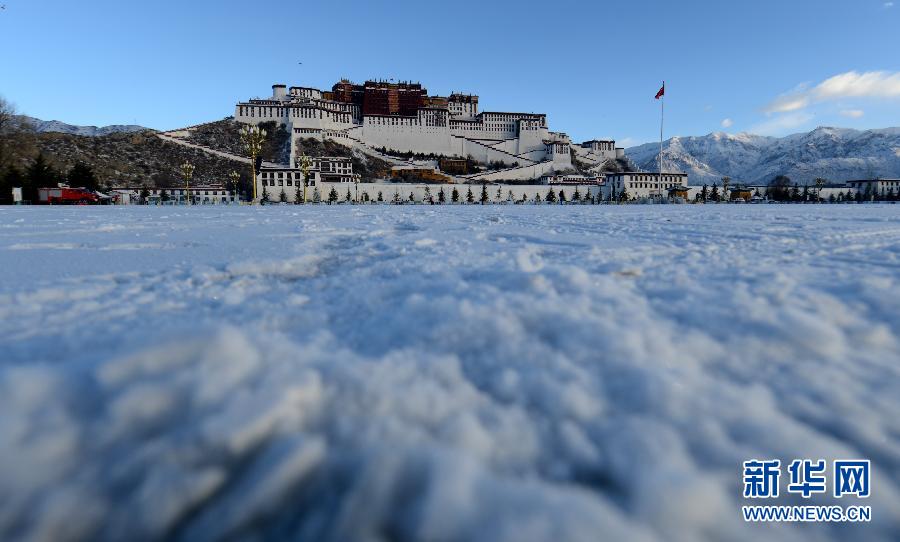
[0,0,900,145]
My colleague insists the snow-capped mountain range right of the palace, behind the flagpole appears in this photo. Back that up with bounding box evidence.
[626,127,900,185]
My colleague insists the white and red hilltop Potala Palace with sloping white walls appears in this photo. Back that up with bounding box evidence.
[235,80,624,182]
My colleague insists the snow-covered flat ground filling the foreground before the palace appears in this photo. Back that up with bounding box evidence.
[0,205,900,542]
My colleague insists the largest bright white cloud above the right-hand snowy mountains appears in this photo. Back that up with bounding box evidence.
[763,71,900,114]
